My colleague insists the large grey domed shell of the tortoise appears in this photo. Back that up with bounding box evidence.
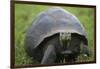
[25,7,87,54]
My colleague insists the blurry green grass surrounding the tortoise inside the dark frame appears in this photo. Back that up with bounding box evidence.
[15,4,94,65]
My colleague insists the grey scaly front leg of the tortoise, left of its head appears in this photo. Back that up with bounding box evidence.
[41,45,56,64]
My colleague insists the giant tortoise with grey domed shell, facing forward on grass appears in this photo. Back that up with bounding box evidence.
[25,7,89,64]
